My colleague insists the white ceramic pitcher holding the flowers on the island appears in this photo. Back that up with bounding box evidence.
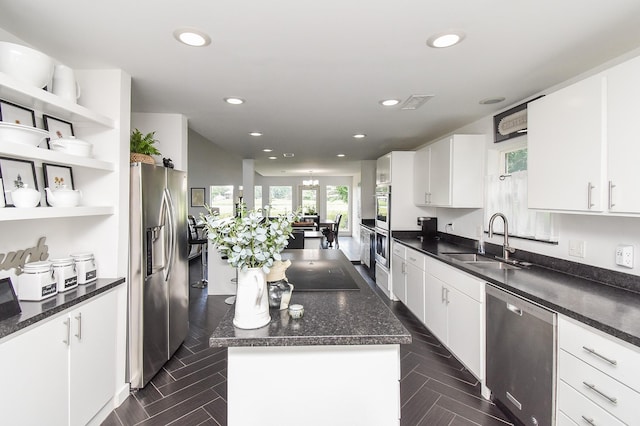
[233,268,271,329]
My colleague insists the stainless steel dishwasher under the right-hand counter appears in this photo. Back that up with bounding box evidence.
[486,284,557,426]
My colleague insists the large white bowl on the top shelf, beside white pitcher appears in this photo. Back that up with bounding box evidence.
[0,41,54,89]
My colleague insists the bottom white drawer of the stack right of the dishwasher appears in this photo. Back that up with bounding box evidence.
[558,380,623,426]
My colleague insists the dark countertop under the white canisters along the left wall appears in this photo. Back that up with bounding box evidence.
[0,278,124,339]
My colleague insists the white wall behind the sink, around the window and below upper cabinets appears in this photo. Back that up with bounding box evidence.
[420,55,640,275]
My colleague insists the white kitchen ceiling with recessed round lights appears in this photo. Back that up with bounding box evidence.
[0,0,640,175]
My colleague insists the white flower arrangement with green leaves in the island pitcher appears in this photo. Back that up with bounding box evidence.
[200,204,299,273]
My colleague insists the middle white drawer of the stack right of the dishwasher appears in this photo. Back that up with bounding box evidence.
[558,350,640,424]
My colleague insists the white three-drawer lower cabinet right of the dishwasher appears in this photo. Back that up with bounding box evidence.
[557,316,640,425]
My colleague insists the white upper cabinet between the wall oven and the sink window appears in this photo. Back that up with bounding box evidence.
[413,135,486,208]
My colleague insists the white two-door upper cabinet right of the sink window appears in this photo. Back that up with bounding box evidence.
[528,53,640,215]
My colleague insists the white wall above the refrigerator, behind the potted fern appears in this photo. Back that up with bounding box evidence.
[131,112,189,172]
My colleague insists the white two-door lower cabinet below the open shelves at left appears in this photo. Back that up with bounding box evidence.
[0,291,118,425]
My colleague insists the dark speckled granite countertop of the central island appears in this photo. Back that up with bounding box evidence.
[209,249,411,347]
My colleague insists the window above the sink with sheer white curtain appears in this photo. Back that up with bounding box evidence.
[484,146,557,241]
